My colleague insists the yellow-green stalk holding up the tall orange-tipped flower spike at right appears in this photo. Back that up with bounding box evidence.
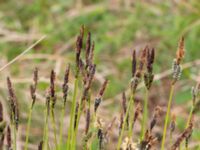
[161,84,174,150]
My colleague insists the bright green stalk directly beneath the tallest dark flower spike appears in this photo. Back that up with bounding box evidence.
[67,77,79,149]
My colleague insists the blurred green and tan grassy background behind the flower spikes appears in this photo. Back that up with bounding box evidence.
[0,0,200,149]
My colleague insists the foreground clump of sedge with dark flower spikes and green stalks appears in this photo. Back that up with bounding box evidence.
[0,26,199,150]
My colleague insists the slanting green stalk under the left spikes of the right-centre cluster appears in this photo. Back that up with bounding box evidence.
[117,95,133,150]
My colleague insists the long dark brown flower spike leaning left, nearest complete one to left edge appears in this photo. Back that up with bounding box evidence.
[7,77,19,129]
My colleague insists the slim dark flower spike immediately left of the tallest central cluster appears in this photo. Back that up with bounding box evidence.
[62,65,70,105]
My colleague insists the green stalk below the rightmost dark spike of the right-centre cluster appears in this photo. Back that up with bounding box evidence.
[140,89,149,140]
